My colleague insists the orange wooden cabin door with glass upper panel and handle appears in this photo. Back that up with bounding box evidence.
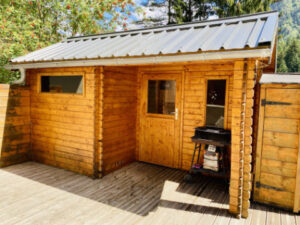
[139,74,181,168]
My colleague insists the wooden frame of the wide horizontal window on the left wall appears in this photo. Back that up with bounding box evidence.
[37,72,86,97]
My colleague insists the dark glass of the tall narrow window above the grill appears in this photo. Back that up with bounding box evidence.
[206,80,226,128]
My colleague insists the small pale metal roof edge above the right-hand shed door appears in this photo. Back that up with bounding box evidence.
[259,73,300,84]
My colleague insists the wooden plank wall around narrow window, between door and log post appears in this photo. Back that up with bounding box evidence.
[136,61,233,170]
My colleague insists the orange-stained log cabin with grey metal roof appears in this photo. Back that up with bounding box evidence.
[0,11,278,217]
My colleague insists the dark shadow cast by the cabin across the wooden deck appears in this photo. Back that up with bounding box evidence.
[4,162,228,216]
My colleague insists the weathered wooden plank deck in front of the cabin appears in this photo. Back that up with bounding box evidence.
[0,162,299,224]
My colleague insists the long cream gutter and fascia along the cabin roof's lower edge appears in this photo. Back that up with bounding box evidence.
[5,48,272,70]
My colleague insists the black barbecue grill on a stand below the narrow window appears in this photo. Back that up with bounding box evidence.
[184,126,231,183]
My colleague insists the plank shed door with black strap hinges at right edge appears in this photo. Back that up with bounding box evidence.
[254,88,300,212]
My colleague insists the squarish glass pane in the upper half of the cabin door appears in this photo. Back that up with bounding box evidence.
[148,80,176,115]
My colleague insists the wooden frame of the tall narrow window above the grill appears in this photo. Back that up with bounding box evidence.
[203,76,230,129]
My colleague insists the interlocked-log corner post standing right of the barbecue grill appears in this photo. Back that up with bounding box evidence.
[229,61,256,218]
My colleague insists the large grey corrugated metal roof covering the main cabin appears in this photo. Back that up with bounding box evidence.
[12,11,278,63]
